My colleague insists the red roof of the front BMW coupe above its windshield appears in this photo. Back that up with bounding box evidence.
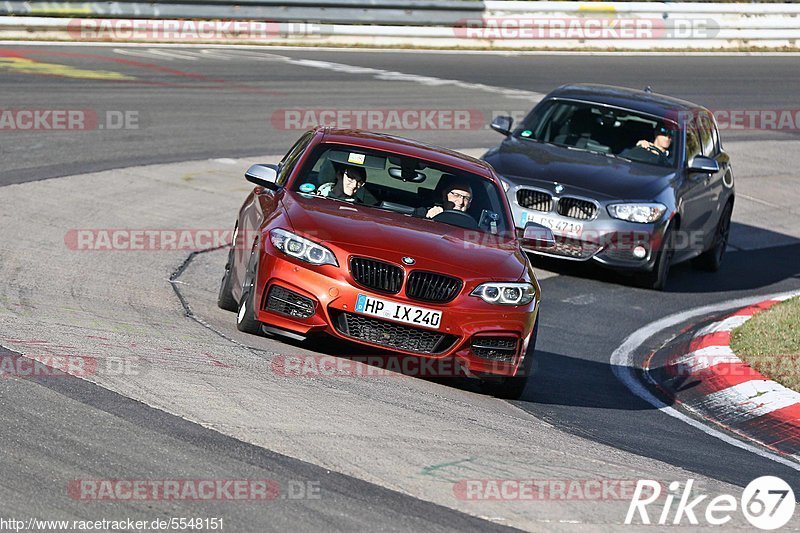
[317,127,494,179]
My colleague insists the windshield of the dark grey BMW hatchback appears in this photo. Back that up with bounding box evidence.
[514,99,679,167]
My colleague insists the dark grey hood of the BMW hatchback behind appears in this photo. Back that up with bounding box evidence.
[483,138,675,201]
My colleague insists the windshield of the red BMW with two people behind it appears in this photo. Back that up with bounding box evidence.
[291,144,512,236]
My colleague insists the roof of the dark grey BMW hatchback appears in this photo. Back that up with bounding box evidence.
[546,83,707,117]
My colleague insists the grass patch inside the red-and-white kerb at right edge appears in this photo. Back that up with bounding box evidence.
[731,296,800,391]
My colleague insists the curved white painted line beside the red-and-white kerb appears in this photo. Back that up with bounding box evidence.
[611,291,800,471]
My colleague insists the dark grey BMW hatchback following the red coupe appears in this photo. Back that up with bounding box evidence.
[483,84,735,290]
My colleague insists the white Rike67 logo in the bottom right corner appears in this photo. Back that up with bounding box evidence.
[625,476,795,530]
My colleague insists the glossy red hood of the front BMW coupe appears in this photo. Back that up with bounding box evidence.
[282,191,527,281]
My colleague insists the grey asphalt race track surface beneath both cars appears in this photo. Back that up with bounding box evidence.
[0,44,800,531]
